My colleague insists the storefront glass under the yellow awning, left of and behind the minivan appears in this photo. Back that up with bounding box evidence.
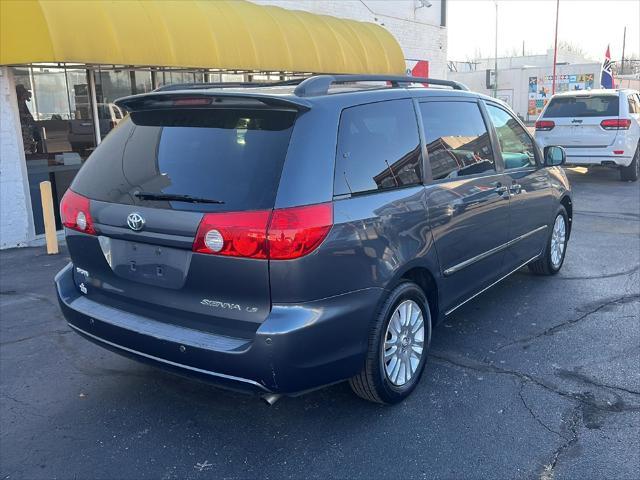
[13,66,245,234]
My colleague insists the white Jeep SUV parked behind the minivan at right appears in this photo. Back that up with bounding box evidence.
[535,90,640,182]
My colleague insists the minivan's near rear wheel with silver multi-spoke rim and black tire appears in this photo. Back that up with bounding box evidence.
[349,282,431,404]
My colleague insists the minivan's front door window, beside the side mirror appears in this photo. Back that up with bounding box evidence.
[487,105,536,170]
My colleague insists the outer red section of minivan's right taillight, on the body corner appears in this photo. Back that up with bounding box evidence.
[268,203,333,260]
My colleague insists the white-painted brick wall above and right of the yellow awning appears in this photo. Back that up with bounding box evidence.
[252,0,448,78]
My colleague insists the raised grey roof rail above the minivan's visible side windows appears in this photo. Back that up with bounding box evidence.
[293,75,469,97]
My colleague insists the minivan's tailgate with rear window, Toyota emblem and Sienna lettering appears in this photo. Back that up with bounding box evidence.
[63,96,298,336]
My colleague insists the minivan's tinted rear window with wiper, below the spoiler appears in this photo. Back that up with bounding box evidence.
[71,109,296,211]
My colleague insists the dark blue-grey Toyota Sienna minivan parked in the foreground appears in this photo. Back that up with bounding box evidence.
[55,75,573,403]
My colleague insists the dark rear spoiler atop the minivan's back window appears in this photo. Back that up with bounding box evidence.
[115,90,311,112]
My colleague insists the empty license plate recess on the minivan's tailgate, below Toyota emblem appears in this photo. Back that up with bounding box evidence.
[99,237,191,289]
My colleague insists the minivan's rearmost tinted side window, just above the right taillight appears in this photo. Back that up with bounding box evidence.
[334,100,422,195]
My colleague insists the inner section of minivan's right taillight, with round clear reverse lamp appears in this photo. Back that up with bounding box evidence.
[193,210,271,258]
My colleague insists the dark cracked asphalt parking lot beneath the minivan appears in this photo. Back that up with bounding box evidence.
[0,170,640,480]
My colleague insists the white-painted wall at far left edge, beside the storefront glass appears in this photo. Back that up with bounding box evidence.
[0,67,35,248]
